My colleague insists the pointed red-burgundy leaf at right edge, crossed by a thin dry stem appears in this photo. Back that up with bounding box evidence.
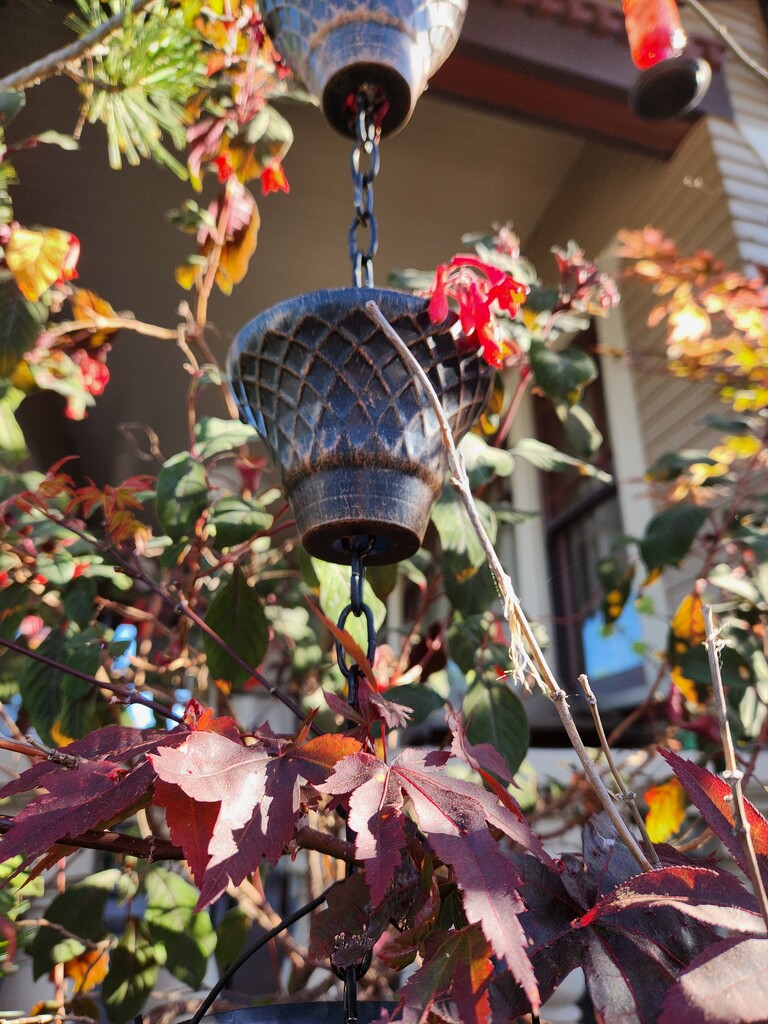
[658,750,768,886]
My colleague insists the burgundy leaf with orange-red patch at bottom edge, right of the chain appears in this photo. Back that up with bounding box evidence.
[401,926,494,1024]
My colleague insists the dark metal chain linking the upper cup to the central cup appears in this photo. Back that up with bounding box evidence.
[349,89,381,288]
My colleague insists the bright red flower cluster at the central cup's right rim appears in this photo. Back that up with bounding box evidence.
[429,255,528,367]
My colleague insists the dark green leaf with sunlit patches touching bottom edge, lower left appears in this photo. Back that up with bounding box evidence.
[101,918,165,1024]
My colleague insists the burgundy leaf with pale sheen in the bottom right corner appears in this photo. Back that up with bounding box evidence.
[658,938,768,1024]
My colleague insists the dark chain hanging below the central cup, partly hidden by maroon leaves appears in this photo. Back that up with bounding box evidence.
[334,532,376,1011]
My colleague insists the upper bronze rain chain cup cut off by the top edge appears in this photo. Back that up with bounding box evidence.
[260,0,467,135]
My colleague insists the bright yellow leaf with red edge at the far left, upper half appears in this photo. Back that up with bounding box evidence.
[5,227,80,302]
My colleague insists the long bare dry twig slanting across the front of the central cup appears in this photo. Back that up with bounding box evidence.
[366,302,653,871]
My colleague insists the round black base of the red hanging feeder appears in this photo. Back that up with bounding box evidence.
[630,56,712,121]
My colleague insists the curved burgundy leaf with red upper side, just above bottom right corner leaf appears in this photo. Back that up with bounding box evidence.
[574,867,766,935]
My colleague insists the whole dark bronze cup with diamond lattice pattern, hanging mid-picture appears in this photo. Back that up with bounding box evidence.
[228,288,494,565]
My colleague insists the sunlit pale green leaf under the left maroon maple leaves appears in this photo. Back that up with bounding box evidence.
[144,867,216,988]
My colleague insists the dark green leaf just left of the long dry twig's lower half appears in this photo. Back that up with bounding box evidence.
[462,678,530,775]
